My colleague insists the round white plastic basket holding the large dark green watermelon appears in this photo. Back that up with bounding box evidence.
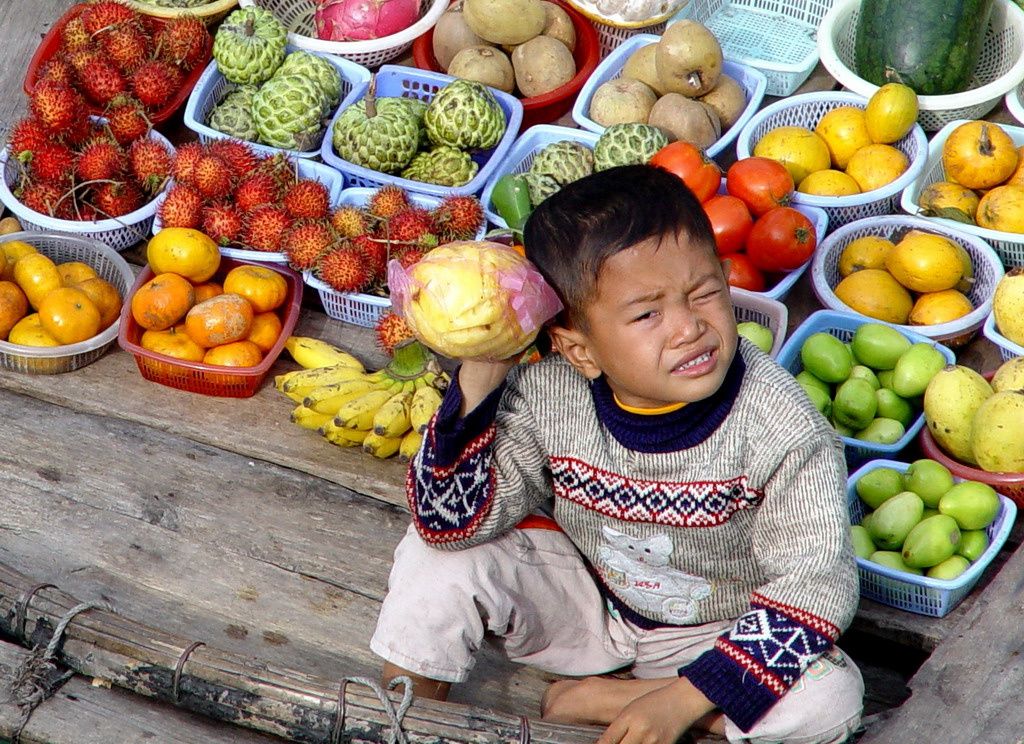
[818,0,1024,132]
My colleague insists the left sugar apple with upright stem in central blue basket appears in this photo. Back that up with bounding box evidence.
[331,92,423,173]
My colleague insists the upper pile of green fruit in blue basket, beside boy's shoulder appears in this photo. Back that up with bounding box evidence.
[796,322,947,444]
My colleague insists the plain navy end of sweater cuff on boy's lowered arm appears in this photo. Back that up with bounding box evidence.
[679,648,779,732]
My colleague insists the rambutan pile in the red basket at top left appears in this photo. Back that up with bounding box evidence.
[33,0,212,117]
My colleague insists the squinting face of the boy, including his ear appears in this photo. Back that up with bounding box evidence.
[552,234,737,408]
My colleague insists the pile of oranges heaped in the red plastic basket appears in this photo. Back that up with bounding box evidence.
[130,227,288,367]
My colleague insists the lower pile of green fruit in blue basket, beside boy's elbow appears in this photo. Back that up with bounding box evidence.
[850,457,1000,580]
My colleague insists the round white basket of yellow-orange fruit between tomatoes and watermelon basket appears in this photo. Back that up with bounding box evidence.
[736,91,928,229]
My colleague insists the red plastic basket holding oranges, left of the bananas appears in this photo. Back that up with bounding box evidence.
[118,258,302,398]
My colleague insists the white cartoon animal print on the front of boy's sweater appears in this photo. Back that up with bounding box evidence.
[597,525,711,623]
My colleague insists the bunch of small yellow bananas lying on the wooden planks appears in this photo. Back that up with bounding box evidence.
[274,336,449,461]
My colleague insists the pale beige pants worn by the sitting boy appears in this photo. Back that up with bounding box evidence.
[370,527,864,744]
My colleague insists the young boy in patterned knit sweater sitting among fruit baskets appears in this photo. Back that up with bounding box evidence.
[371,166,863,744]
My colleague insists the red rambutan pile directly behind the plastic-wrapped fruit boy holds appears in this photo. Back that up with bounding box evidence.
[301,184,484,297]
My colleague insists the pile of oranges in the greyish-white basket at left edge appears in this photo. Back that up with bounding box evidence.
[0,240,122,347]
